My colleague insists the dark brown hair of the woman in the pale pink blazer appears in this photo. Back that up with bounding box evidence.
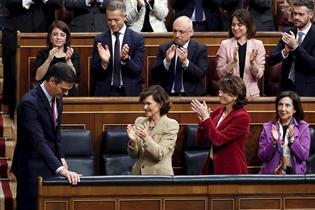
[229,9,256,39]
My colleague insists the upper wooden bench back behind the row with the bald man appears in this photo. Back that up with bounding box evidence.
[17,32,281,100]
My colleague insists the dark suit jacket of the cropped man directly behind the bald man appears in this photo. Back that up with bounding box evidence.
[172,0,223,31]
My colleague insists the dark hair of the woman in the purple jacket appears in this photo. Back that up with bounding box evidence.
[275,90,304,122]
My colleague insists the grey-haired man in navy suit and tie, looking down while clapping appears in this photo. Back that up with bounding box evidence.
[92,0,144,96]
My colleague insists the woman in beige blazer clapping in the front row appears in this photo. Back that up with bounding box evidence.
[127,85,179,175]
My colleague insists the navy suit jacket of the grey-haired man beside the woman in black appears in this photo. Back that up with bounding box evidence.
[92,28,144,96]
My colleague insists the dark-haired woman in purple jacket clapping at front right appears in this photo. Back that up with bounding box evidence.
[258,91,310,174]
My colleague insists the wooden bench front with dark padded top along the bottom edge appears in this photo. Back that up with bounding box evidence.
[38,175,315,210]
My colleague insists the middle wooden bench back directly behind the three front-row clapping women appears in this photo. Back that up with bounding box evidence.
[62,97,315,174]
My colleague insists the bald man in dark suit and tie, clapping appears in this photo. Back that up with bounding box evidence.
[151,16,208,96]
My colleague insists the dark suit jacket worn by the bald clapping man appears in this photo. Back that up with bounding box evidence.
[151,39,208,96]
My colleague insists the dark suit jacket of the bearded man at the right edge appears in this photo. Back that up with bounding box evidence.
[268,25,315,96]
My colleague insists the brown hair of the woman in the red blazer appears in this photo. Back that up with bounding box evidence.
[219,75,247,109]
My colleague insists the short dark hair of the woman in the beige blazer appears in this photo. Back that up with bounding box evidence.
[139,85,171,116]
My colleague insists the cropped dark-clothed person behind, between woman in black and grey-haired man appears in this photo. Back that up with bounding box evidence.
[64,0,108,32]
